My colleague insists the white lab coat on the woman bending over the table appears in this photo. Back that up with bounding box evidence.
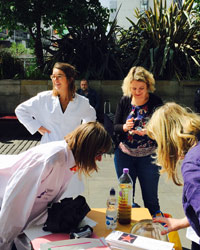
[0,141,82,250]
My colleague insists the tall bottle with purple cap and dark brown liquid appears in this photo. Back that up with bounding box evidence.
[118,168,133,224]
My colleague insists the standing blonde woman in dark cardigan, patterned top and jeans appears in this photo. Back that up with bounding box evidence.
[114,67,163,215]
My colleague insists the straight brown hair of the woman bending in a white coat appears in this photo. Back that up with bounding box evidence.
[65,122,112,175]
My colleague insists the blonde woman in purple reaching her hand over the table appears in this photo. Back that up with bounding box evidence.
[146,102,200,250]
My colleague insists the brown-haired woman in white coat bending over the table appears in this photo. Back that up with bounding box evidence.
[0,122,111,250]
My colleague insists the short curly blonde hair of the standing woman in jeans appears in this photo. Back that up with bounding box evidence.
[122,66,155,97]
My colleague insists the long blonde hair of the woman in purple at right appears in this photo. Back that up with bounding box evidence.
[146,102,200,186]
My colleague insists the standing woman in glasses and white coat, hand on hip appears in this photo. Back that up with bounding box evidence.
[15,62,96,143]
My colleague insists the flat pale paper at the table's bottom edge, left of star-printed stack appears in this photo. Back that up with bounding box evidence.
[40,238,109,250]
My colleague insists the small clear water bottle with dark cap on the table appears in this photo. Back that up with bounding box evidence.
[106,188,117,230]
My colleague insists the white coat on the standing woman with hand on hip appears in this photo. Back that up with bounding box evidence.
[15,91,96,143]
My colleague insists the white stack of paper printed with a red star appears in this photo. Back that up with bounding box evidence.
[105,231,174,250]
